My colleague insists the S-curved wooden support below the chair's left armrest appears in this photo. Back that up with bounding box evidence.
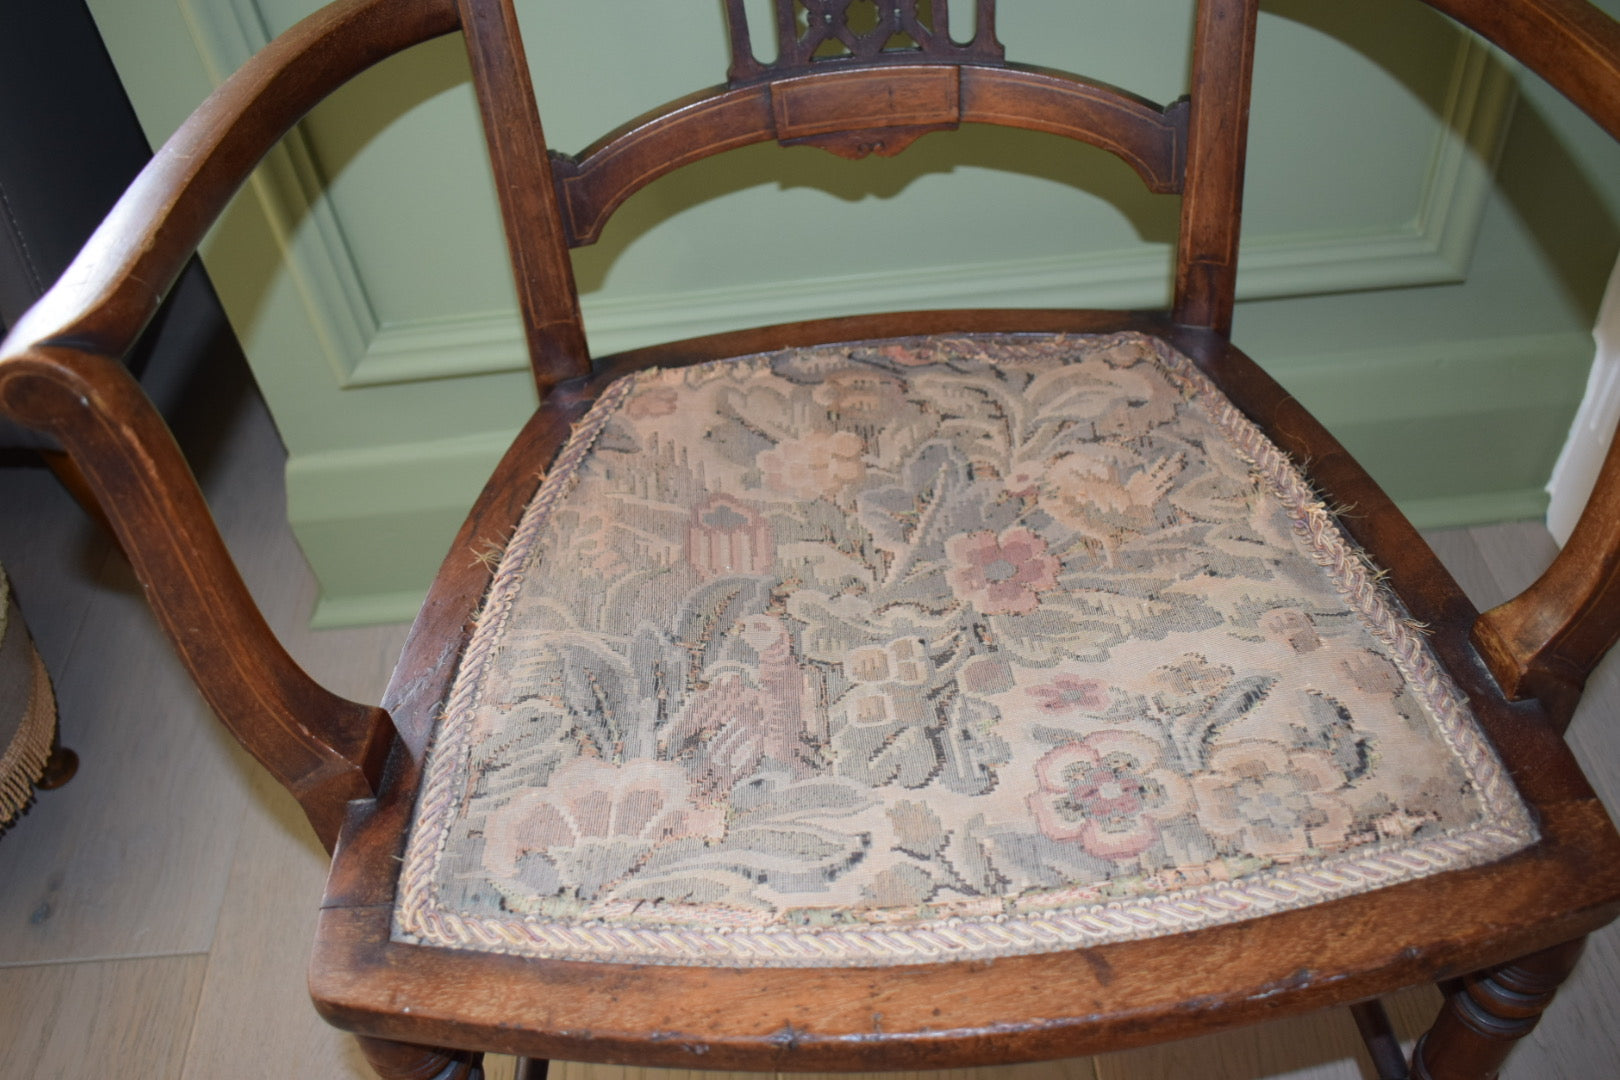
[0,348,394,847]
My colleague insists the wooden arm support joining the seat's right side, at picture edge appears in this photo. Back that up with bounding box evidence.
[1473,417,1620,724]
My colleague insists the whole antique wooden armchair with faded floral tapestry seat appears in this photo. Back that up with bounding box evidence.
[0,0,1620,1077]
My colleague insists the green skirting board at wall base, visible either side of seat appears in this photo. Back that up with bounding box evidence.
[287,334,1591,627]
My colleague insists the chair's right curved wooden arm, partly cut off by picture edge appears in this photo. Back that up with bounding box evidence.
[1427,0,1620,724]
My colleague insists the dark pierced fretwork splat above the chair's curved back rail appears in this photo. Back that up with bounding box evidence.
[726,0,1004,86]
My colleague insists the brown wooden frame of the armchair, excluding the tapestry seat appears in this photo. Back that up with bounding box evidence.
[0,0,1620,1077]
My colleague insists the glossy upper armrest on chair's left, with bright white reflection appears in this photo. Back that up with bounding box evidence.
[3,0,460,367]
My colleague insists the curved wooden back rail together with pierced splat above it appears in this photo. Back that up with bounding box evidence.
[551,0,1187,246]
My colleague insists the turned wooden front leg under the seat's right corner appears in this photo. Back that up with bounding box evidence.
[1411,938,1586,1080]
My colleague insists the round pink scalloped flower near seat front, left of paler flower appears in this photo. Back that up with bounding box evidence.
[1029,730,1192,860]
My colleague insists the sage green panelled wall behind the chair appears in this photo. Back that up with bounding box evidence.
[91,0,1620,622]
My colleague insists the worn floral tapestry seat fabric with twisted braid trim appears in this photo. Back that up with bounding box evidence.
[394,335,1534,967]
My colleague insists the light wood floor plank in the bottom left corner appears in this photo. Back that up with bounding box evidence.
[0,955,207,1080]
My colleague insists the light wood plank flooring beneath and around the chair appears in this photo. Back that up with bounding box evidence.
[0,374,1620,1080]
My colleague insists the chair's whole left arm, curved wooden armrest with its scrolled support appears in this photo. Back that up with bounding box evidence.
[0,0,460,848]
